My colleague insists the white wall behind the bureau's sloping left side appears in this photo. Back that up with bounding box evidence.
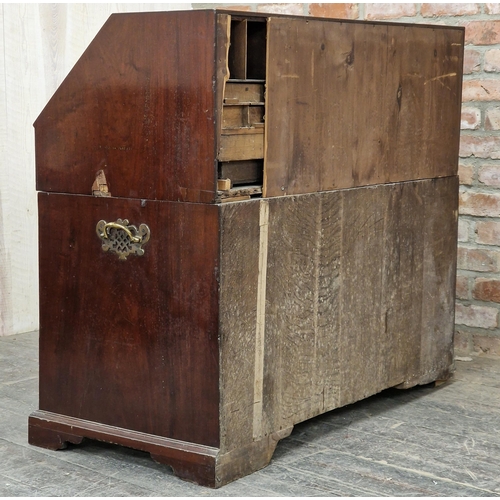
[0,3,191,335]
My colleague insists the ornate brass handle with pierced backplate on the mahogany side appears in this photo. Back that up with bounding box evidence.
[96,219,150,260]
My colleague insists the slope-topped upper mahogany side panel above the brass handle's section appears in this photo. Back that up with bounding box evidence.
[35,11,215,202]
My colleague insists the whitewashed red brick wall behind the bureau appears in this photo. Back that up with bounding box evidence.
[215,3,500,356]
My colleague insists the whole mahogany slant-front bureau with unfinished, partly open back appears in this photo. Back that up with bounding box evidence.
[29,10,464,487]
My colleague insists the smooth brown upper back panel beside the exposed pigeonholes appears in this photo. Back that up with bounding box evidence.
[264,18,463,196]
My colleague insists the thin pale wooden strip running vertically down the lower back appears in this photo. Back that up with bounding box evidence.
[253,200,269,439]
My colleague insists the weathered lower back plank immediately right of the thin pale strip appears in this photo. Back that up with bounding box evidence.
[265,195,321,429]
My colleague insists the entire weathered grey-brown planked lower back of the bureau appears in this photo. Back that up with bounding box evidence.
[221,177,458,450]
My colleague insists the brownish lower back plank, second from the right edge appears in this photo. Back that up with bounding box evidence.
[382,182,426,387]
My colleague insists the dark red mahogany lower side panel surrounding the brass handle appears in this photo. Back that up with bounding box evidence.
[39,194,219,446]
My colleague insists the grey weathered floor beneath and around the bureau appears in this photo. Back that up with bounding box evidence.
[0,333,500,497]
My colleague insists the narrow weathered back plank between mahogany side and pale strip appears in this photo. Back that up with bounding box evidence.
[219,200,261,454]
